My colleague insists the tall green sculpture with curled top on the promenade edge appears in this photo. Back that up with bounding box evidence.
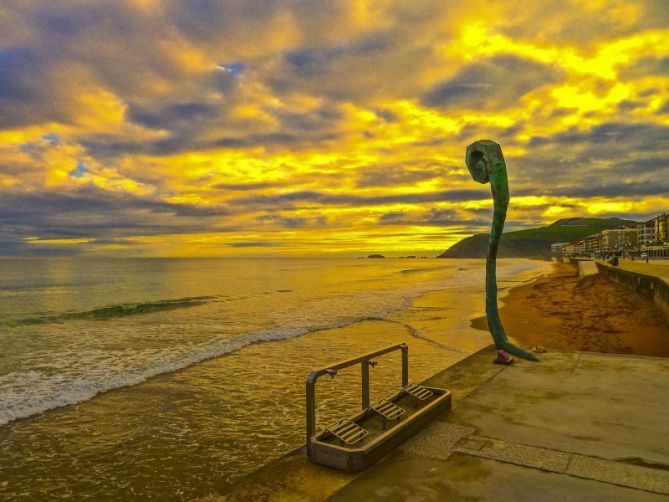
[465,139,538,361]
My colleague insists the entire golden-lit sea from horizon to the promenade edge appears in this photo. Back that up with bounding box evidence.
[0,257,549,500]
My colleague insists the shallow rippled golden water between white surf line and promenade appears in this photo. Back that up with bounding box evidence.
[0,261,548,498]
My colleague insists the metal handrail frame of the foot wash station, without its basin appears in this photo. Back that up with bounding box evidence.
[306,343,409,456]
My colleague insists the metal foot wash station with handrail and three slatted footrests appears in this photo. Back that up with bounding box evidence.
[306,343,451,472]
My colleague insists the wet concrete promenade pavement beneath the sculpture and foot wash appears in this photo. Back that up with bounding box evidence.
[220,349,669,501]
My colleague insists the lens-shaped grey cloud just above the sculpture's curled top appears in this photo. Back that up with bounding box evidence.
[421,55,560,110]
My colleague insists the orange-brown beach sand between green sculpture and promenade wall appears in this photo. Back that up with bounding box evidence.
[472,264,669,357]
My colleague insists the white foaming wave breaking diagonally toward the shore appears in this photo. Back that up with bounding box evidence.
[0,288,423,426]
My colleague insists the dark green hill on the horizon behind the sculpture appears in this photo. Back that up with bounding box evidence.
[437,218,637,259]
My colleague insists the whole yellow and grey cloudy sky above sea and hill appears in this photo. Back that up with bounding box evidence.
[0,0,669,257]
